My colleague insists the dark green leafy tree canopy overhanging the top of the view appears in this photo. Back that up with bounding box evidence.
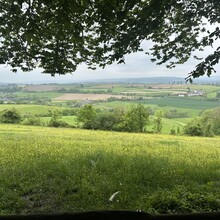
[0,0,220,79]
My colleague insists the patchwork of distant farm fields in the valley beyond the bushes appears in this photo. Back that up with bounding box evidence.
[0,83,220,134]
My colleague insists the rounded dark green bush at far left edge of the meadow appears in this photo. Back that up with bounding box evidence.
[0,108,22,124]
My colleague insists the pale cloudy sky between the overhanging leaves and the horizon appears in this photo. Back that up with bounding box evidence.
[0,41,220,83]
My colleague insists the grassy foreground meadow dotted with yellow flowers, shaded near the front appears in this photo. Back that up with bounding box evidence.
[0,124,220,214]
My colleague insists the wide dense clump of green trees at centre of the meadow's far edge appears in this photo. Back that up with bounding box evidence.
[77,104,149,132]
